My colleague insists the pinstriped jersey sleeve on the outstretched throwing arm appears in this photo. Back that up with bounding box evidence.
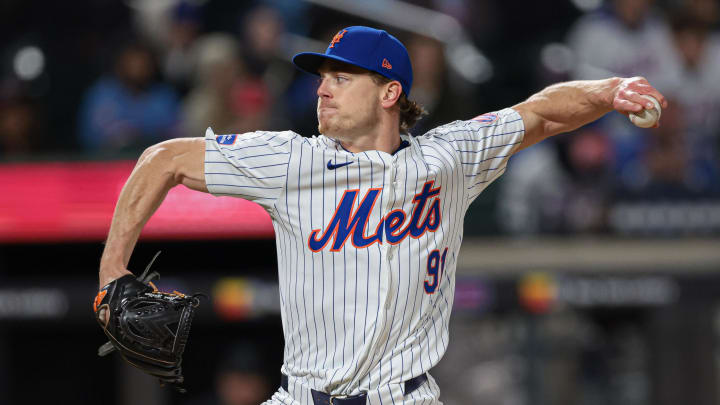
[438,108,525,203]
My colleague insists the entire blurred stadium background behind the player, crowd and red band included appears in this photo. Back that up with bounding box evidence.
[0,0,720,405]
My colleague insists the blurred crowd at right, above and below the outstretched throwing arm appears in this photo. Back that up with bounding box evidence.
[500,0,720,236]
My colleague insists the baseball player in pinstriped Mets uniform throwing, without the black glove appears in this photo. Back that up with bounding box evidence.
[100,27,666,405]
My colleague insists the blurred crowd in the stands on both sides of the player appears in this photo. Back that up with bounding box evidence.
[0,0,720,235]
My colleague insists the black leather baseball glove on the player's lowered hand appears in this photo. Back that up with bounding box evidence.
[93,252,202,392]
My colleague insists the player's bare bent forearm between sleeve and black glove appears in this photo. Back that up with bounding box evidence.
[100,145,178,286]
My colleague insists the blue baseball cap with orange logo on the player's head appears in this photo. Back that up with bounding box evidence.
[293,26,412,97]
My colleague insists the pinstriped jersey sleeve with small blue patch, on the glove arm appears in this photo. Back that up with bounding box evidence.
[205,128,298,210]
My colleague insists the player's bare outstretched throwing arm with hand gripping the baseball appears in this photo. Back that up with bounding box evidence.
[512,77,667,149]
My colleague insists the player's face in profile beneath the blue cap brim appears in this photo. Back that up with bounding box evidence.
[317,63,382,140]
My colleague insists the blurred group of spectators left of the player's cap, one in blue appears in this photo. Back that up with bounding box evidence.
[77,1,294,152]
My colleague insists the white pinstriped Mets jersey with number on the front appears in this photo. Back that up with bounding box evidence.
[205,109,524,403]
